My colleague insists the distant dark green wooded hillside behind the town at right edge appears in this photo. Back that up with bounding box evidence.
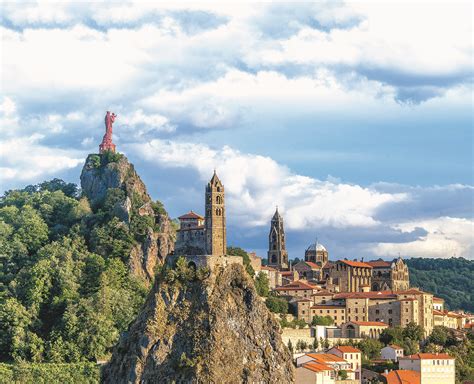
[405,257,474,312]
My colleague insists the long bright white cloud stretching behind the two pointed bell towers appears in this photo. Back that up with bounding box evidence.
[128,140,405,229]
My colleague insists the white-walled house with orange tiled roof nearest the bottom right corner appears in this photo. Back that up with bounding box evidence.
[398,353,455,384]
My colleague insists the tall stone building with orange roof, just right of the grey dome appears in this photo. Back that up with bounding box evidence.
[329,260,372,292]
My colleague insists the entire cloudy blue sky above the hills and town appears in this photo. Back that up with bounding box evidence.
[0,1,474,260]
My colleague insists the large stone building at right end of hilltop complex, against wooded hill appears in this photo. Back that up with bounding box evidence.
[367,257,410,291]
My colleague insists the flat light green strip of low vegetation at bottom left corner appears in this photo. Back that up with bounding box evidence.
[0,363,100,384]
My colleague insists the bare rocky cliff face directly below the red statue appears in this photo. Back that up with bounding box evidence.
[81,154,175,281]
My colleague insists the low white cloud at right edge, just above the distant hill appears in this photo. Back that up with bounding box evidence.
[371,217,474,259]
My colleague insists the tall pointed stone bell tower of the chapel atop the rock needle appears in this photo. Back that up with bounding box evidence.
[205,171,227,255]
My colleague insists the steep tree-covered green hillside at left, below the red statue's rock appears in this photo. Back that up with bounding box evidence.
[0,155,174,363]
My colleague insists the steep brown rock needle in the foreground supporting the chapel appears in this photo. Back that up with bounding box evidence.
[102,264,294,383]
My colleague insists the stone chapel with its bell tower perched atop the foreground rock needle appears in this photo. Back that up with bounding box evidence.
[175,171,227,256]
